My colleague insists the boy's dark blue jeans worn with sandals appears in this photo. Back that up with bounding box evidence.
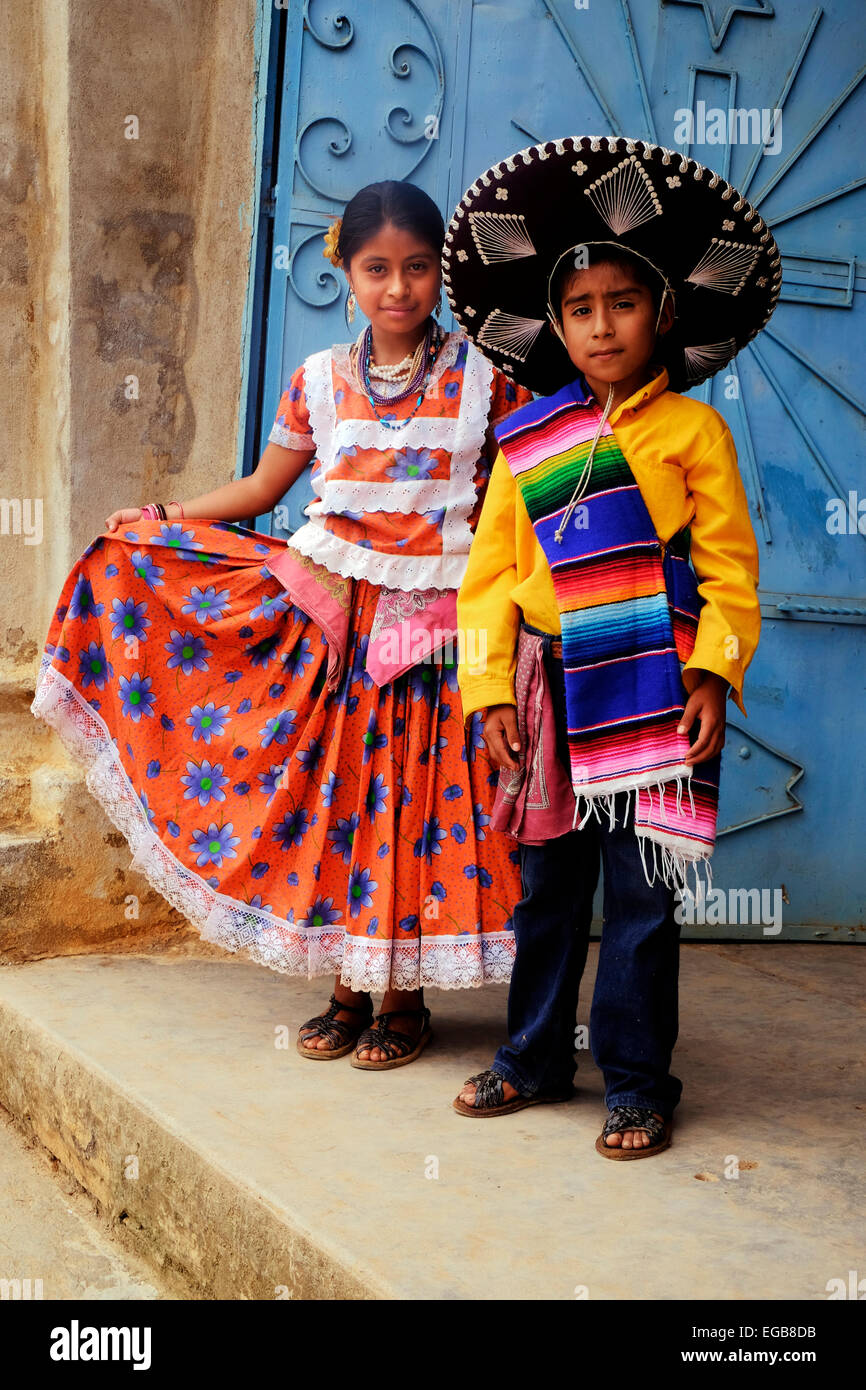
[493,628,683,1119]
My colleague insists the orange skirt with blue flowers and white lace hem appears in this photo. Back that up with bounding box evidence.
[32,520,521,990]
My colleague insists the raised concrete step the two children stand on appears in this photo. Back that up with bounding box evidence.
[0,942,866,1300]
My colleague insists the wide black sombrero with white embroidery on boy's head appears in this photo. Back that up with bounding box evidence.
[442,135,781,395]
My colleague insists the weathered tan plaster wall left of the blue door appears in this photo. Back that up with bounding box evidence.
[0,0,264,959]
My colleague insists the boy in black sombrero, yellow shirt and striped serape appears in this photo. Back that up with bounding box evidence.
[445,139,778,1159]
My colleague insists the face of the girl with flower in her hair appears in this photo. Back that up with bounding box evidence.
[346,222,442,341]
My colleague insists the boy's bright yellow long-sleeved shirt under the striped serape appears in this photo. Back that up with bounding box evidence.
[457,370,760,719]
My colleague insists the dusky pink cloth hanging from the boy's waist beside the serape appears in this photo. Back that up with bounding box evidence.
[491,627,574,845]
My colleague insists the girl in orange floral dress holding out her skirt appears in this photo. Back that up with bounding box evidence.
[32,182,531,1069]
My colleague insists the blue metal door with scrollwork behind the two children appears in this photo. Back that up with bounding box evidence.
[256,0,866,941]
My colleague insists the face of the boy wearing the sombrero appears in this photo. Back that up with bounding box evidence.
[560,261,673,404]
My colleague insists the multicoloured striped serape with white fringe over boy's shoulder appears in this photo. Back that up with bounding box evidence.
[496,378,720,888]
